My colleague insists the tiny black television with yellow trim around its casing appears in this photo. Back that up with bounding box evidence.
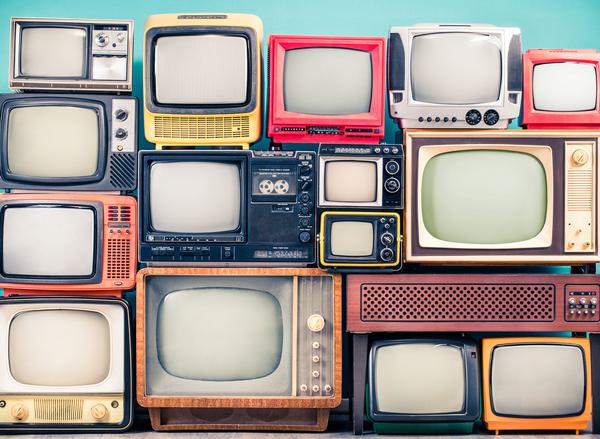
[318,210,402,271]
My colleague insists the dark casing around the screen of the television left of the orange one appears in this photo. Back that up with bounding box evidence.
[366,338,480,423]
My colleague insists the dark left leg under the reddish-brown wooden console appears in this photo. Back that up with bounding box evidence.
[352,334,369,435]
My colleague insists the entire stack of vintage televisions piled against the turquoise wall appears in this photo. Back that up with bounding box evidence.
[0,10,600,434]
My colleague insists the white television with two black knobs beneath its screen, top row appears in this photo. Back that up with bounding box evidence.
[388,24,522,129]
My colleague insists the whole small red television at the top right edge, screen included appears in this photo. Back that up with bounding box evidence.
[521,49,600,129]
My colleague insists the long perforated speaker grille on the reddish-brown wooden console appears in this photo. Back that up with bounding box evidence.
[361,284,555,322]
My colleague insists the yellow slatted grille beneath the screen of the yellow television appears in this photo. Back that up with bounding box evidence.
[154,116,250,140]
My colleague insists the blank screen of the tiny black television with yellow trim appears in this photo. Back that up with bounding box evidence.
[329,221,375,256]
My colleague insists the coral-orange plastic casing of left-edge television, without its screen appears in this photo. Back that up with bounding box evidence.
[0,193,137,297]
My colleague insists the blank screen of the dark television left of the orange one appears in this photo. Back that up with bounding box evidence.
[375,343,465,414]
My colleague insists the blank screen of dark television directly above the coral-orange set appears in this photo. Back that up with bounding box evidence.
[7,105,100,178]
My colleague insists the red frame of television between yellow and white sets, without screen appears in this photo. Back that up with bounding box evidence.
[268,35,385,143]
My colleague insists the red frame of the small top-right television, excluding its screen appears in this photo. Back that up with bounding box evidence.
[521,49,600,129]
